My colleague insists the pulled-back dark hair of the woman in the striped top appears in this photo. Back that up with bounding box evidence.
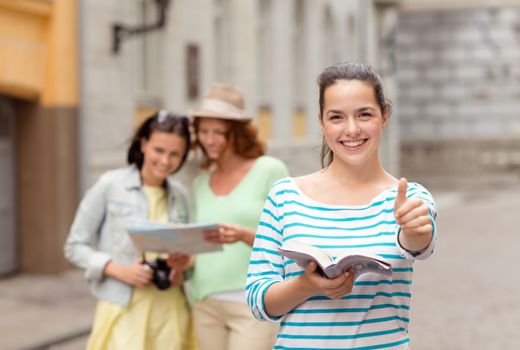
[318,62,392,168]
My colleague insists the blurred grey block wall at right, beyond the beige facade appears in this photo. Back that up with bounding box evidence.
[396,7,520,183]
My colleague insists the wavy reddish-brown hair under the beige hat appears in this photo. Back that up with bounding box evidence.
[193,118,265,169]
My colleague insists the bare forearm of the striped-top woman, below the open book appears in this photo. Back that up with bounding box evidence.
[264,276,313,317]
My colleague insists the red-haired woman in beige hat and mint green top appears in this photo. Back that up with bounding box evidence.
[190,84,288,350]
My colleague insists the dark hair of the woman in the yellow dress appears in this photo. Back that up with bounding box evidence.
[126,110,191,173]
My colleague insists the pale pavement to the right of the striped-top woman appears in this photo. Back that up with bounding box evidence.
[410,183,520,350]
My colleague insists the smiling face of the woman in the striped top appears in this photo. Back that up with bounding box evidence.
[320,80,388,165]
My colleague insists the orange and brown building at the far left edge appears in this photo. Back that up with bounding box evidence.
[0,0,78,275]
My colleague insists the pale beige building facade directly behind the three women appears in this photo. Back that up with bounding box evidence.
[80,0,399,189]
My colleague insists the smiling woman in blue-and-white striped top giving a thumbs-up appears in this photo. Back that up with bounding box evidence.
[247,63,436,349]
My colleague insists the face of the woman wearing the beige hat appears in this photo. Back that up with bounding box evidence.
[197,118,230,161]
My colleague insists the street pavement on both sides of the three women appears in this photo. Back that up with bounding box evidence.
[0,183,520,350]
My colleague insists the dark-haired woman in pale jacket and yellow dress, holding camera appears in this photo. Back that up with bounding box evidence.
[65,111,191,350]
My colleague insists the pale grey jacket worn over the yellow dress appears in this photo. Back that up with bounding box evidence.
[64,166,190,306]
